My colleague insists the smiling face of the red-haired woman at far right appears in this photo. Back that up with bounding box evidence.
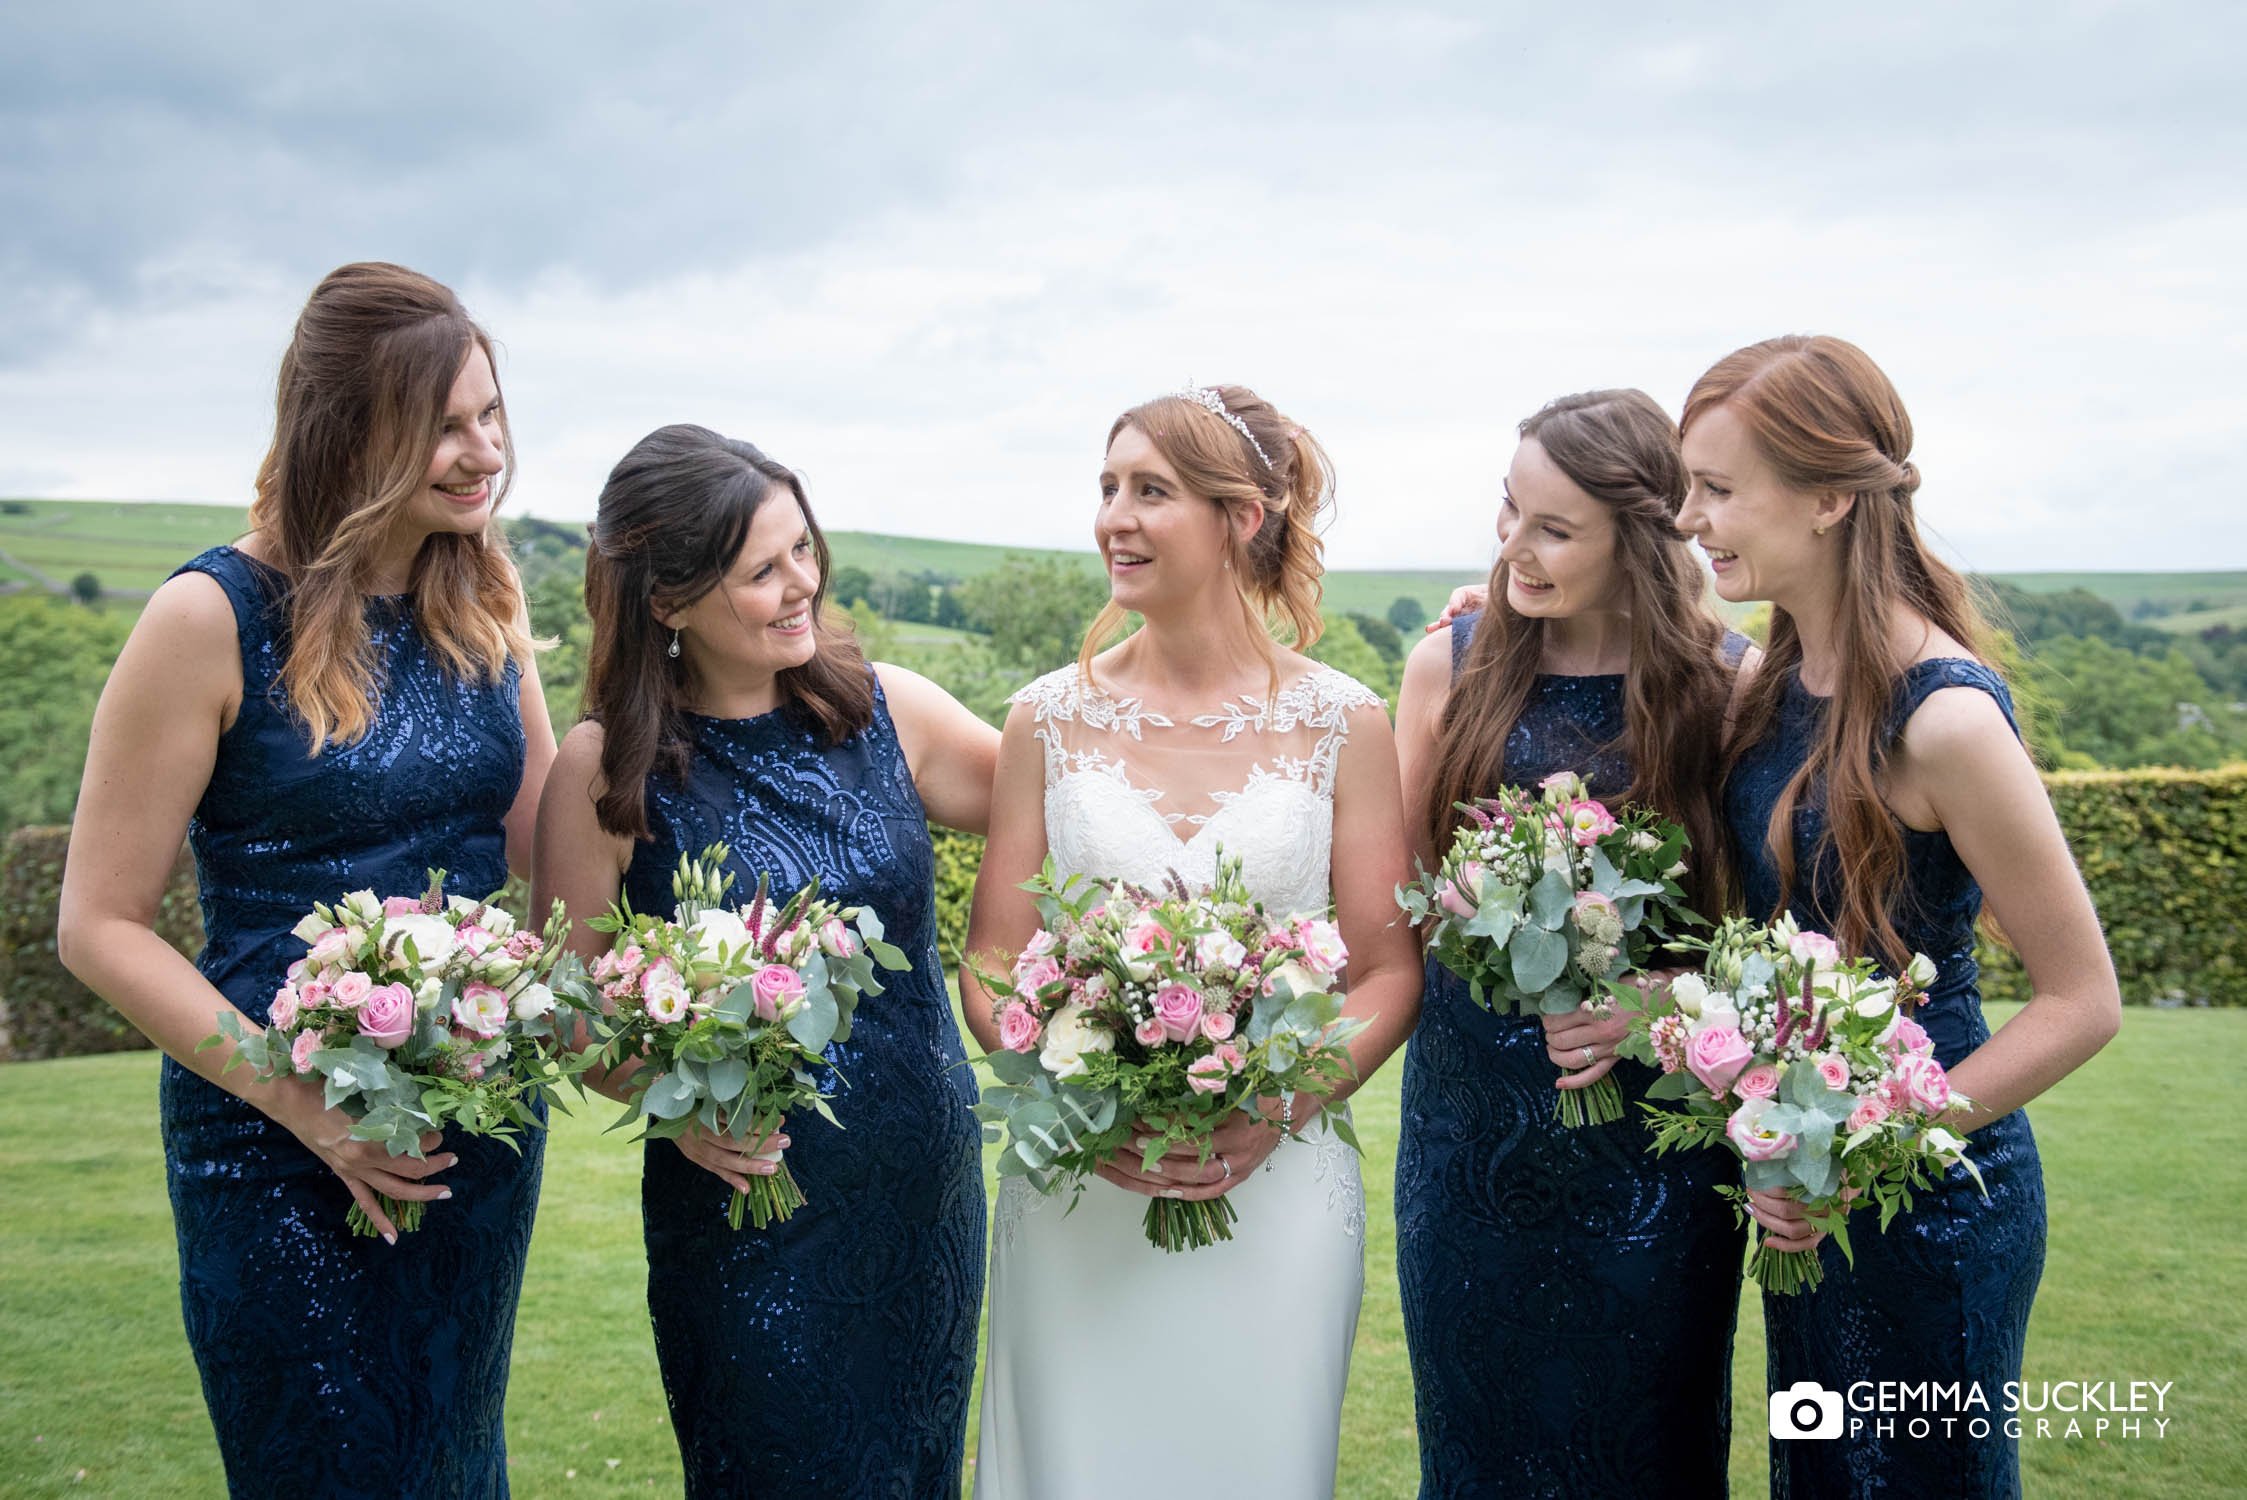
[1679,406,1840,604]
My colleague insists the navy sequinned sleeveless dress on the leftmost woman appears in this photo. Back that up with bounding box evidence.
[162,548,546,1498]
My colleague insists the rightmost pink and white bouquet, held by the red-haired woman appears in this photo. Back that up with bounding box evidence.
[1620,916,1982,1296]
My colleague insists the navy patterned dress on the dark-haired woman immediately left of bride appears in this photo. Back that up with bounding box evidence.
[625,683,984,1500]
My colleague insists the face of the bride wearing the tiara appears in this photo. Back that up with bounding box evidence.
[1092,424,1231,615]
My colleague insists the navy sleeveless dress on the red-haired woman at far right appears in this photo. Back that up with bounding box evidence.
[1726,658,2045,1500]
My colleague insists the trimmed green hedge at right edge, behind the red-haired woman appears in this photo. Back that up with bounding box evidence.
[1980,766,2247,1006]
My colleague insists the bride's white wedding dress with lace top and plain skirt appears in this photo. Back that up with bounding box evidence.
[975,667,1382,1500]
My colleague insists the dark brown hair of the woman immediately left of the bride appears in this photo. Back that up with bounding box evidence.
[584,424,874,840]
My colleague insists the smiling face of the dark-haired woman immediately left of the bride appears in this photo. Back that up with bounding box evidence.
[656,487,820,680]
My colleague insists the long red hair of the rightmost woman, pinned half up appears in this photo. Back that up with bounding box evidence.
[1685,335,1989,968]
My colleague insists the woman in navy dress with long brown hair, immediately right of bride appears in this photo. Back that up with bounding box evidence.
[1395,391,1748,1498]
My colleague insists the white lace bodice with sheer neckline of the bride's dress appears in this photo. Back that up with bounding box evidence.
[1013,667,1382,912]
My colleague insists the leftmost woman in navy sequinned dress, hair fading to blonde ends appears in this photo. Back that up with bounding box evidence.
[56,265,553,1496]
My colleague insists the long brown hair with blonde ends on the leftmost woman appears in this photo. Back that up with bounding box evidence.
[249,260,533,754]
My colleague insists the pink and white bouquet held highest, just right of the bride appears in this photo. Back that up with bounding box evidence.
[1398,770,1701,1125]
